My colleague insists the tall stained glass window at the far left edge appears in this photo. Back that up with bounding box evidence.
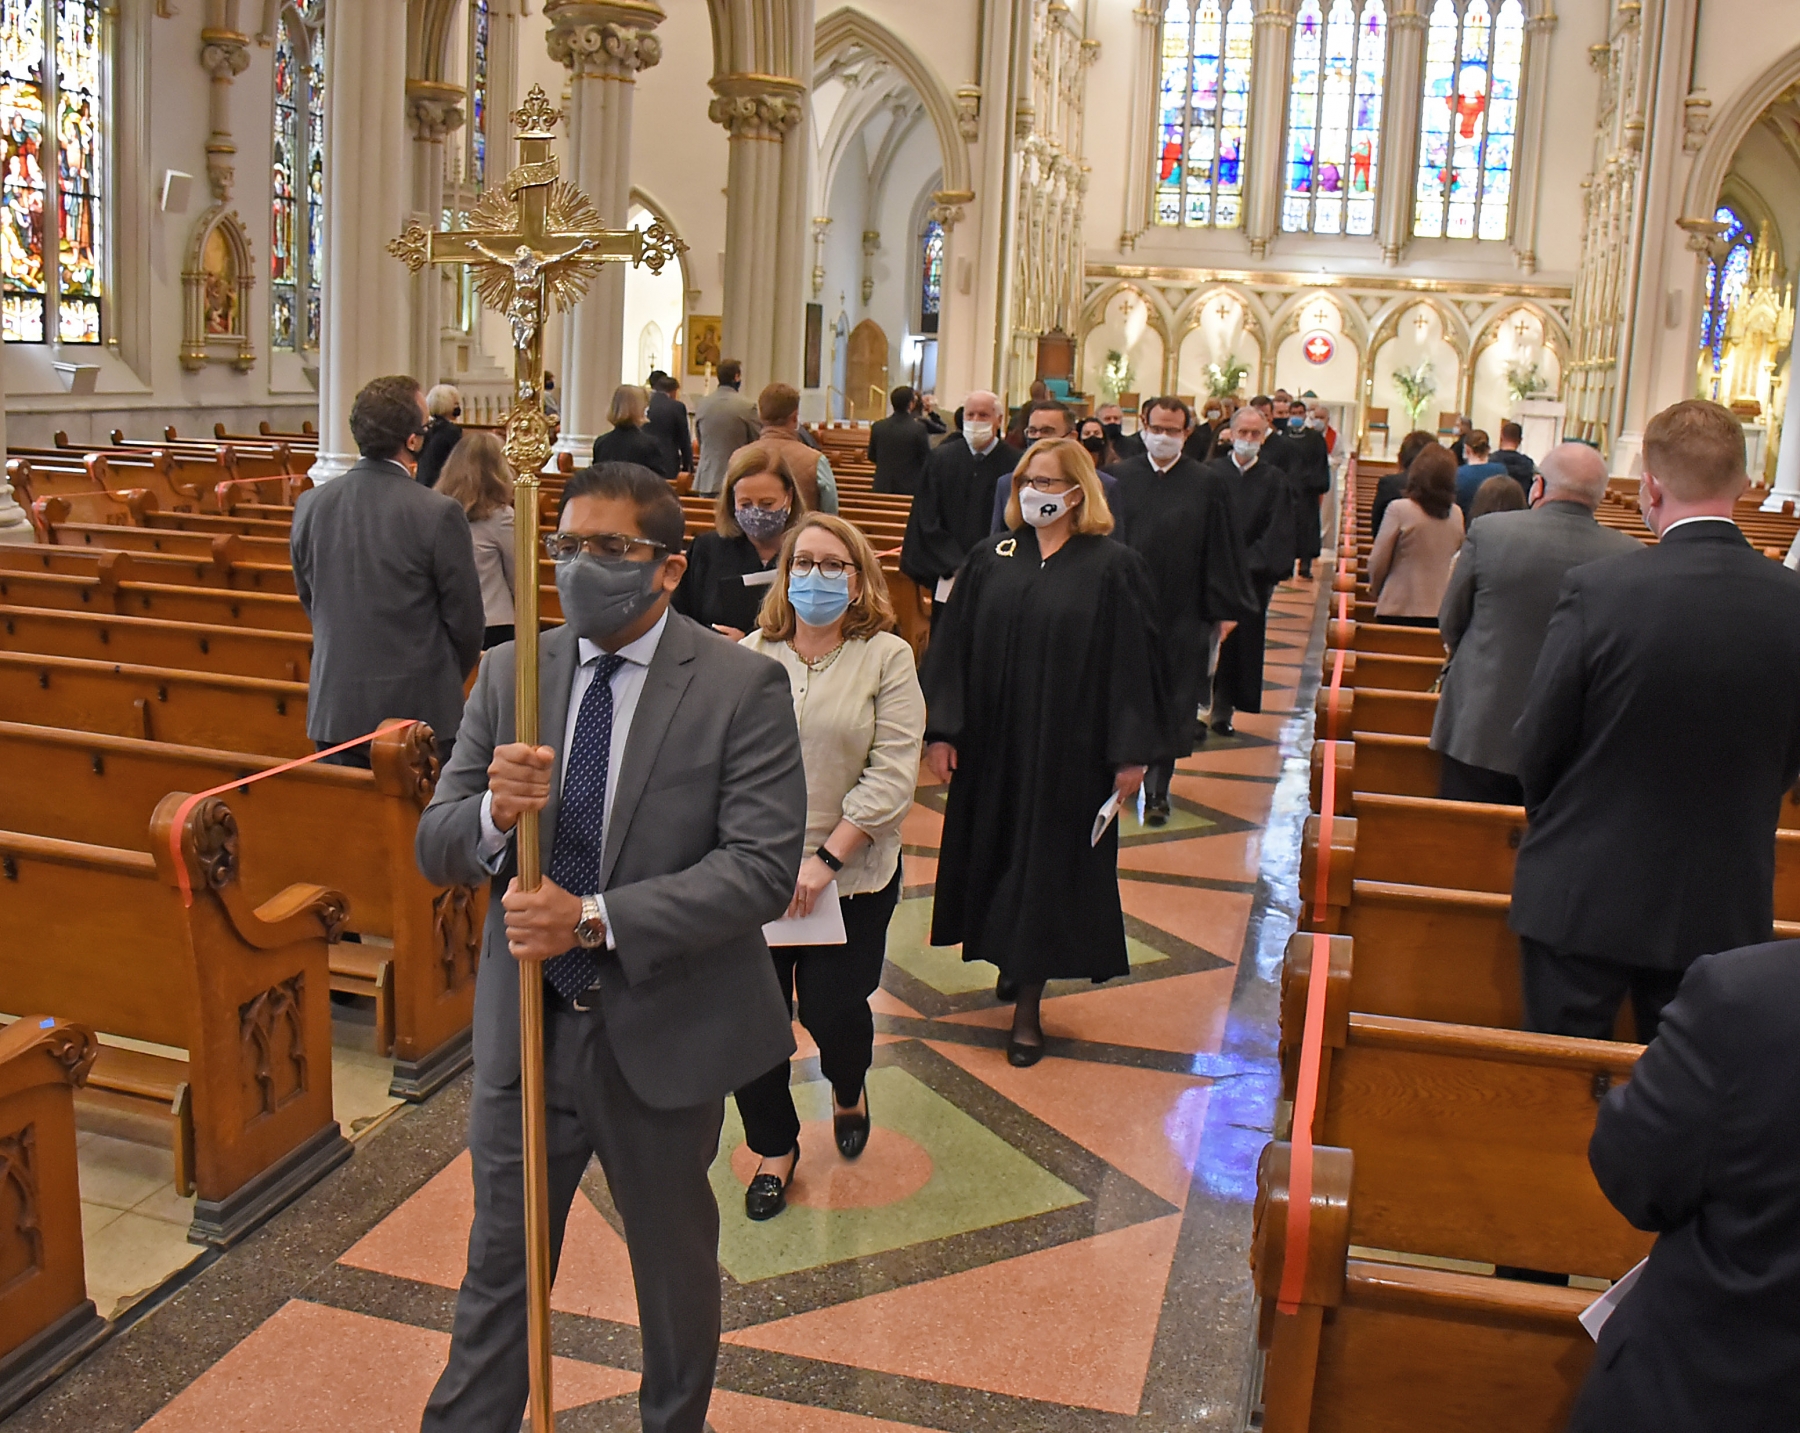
[0,0,104,344]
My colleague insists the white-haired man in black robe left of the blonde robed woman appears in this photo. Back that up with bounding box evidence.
[900,391,1019,628]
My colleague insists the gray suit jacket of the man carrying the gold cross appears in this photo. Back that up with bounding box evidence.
[418,612,806,1109]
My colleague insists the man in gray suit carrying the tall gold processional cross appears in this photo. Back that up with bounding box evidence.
[418,463,806,1433]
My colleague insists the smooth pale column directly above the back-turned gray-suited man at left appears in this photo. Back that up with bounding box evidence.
[311,0,412,482]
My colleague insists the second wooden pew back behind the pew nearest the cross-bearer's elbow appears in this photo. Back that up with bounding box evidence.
[0,607,313,682]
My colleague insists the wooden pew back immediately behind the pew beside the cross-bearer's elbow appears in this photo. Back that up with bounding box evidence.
[0,652,313,756]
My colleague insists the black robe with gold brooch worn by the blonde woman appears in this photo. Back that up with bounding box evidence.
[920,527,1170,981]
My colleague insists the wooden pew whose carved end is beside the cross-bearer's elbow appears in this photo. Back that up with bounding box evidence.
[0,722,488,1100]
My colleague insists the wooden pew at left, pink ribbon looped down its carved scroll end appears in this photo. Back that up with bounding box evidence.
[0,792,351,1246]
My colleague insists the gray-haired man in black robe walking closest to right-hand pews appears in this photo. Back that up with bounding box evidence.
[1206,409,1296,736]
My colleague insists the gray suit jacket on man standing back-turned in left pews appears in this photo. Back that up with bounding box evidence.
[288,457,486,742]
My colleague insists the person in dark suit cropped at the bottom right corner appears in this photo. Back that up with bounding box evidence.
[1570,940,1800,1433]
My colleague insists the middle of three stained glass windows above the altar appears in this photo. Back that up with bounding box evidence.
[1282,0,1388,234]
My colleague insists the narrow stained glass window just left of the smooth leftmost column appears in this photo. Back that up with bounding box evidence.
[268,0,326,353]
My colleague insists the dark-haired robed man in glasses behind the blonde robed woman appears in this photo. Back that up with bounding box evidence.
[1109,398,1262,826]
